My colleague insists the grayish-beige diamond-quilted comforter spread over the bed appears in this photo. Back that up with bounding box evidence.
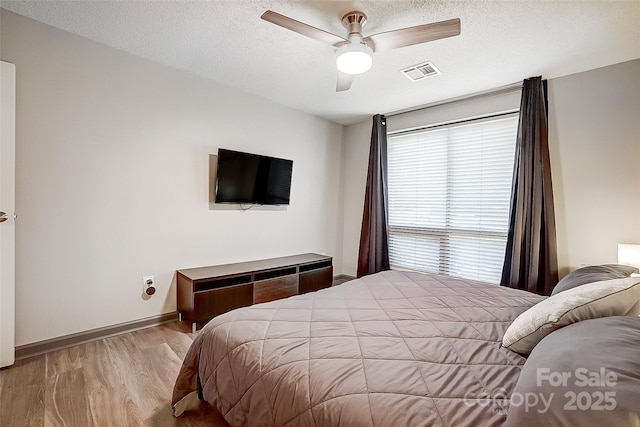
[172,271,544,427]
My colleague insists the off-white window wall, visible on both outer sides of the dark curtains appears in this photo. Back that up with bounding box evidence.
[342,60,640,275]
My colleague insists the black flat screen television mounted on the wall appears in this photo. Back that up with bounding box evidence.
[215,148,293,205]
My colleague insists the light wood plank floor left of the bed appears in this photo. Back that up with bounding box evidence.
[0,322,227,427]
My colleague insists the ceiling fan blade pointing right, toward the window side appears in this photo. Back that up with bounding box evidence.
[363,18,460,52]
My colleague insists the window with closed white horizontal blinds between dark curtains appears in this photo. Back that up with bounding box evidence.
[388,114,518,283]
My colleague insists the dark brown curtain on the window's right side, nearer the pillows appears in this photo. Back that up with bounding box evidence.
[501,77,558,295]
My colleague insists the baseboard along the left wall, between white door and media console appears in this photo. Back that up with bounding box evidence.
[16,311,178,360]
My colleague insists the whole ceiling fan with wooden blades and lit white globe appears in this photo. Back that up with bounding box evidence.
[261,10,460,92]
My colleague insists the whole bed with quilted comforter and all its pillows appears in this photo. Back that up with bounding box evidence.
[172,270,640,427]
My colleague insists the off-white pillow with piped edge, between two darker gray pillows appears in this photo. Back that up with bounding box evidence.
[502,277,640,354]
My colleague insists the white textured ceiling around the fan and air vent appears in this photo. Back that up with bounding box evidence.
[1,0,640,124]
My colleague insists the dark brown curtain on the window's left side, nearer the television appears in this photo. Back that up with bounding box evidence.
[358,114,389,277]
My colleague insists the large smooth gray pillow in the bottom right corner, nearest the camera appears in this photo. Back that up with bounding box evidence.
[505,316,640,427]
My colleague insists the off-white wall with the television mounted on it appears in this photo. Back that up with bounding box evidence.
[1,10,342,345]
